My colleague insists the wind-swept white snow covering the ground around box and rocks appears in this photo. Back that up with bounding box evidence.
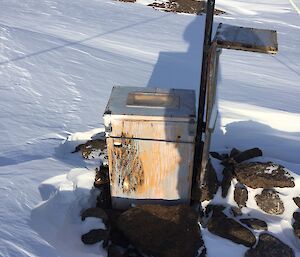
[0,0,300,257]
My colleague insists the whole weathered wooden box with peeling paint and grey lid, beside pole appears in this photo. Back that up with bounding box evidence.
[104,87,196,209]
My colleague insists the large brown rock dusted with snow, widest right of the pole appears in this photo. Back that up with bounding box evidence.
[234,162,295,188]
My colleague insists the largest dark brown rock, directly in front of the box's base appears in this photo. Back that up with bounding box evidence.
[117,205,204,257]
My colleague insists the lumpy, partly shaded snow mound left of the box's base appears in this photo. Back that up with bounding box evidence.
[30,168,105,256]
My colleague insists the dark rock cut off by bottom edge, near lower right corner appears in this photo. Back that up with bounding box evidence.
[245,233,295,257]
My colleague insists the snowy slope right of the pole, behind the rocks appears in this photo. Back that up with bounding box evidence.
[211,1,300,163]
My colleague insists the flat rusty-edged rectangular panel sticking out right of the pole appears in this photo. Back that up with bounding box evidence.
[214,23,278,54]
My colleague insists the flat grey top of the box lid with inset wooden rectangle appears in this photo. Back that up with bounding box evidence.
[104,87,195,119]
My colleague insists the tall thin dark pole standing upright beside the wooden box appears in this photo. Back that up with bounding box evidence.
[192,0,215,199]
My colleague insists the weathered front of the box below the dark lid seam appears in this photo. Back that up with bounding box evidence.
[107,138,194,209]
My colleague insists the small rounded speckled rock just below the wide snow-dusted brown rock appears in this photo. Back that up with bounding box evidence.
[255,189,284,215]
